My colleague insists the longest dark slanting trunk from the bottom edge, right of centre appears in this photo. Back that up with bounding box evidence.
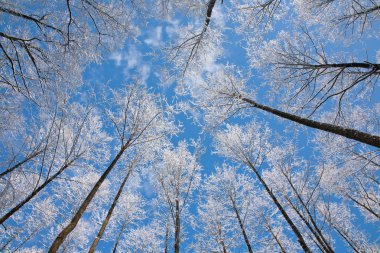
[247,160,311,253]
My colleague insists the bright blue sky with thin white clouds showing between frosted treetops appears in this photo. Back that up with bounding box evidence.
[1,1,380,252]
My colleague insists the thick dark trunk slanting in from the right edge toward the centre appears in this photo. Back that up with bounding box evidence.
[240,97,380,148]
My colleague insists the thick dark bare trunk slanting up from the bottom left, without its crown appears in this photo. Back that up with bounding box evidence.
[48,140,130,253]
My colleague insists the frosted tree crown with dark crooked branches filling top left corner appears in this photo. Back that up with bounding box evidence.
[0,0,131,98]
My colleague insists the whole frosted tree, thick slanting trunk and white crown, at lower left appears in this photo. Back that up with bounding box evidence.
[49,85,175,252]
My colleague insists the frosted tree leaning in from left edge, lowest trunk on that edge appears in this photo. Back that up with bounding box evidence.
[0,103,104,224]
